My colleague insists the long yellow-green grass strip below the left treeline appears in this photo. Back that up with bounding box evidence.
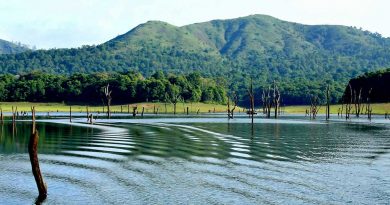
[0,102,235,114]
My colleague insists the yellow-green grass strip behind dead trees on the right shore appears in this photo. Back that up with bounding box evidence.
[284,103,390,114]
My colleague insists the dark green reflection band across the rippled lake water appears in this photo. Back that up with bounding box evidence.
[0,122,387,161]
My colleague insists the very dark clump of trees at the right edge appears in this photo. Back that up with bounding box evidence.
[343,68,390,102]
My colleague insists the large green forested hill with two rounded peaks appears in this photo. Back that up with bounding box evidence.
[0,15,390,104]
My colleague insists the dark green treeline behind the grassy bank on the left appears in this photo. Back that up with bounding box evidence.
[0,71,227,104]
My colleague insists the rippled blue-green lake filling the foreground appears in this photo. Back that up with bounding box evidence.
[0,114,390,204]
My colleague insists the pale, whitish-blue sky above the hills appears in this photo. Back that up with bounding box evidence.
[0,0,390,49]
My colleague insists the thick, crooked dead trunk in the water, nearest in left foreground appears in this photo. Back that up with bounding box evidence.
[28,107,47,201]
